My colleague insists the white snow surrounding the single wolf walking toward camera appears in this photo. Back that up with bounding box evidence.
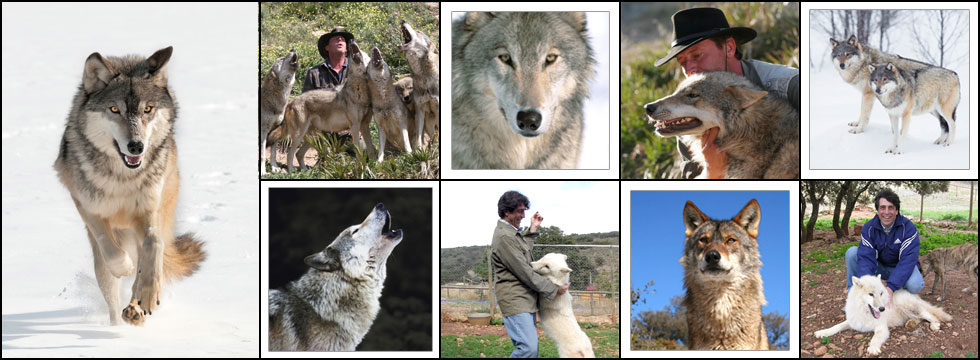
[2,3,260,358]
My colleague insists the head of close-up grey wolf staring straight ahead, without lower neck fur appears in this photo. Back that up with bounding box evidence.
[453,12,595,138]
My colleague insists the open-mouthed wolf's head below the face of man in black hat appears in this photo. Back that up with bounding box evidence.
[643,72,768,137]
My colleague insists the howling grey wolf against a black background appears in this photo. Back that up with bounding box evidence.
[269,204,403,351]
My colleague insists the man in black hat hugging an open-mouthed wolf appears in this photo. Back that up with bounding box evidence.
[654,8,800,179]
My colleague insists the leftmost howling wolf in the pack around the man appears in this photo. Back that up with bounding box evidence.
[259,50,299,175]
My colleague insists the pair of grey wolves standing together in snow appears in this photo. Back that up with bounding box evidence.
[830,35,960,154]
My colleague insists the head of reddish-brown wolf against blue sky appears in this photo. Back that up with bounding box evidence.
[680,199,762,282]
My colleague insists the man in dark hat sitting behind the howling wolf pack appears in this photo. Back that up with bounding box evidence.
[303,28,354,92]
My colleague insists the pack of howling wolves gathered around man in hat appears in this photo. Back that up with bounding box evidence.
[259,22,439,174]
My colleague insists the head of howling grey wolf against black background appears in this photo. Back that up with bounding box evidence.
[305,203,403,280]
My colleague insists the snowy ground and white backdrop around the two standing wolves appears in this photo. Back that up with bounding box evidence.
[804,9,977,170]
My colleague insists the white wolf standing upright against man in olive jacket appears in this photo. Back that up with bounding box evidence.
[531,253,595,358]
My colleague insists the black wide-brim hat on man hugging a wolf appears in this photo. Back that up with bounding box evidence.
[654,8,756,66]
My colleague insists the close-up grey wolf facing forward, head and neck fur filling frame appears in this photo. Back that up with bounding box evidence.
[452,12,595,169]
